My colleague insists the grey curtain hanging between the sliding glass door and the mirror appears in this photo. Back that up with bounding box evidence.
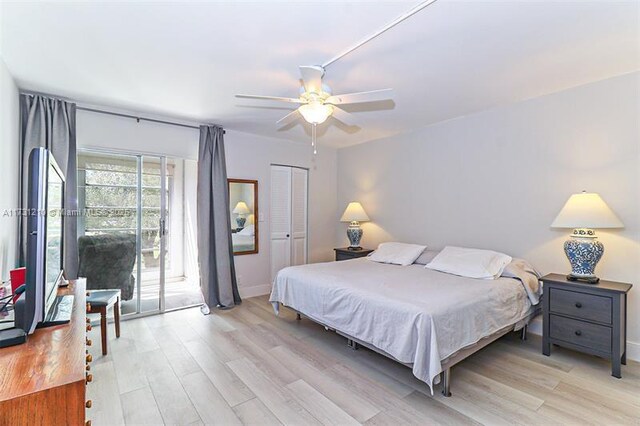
[198,126,242,313]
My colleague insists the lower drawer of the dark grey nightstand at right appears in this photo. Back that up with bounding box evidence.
[549,315,611,353]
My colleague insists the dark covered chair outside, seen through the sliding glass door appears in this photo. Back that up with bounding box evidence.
[78,234,136,300]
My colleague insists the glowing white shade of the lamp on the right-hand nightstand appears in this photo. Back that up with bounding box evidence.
[551,191,624,229]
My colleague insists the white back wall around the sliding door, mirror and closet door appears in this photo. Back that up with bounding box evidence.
[77,111,337,297]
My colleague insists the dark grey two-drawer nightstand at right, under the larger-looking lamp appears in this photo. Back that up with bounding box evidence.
[541,274,632,378]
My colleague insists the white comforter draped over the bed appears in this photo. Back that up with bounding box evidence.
[269,258,537,392]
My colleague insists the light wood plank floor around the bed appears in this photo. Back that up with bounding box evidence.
[87,297,640,425]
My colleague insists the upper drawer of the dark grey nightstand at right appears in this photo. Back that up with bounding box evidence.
[549,288,611,324]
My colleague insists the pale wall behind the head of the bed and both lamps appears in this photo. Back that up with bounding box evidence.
[337,73,640,359]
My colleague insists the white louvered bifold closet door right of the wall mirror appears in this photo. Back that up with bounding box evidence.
[270,166,308,281]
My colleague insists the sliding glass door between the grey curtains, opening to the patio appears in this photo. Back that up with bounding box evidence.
[78,151,201,315]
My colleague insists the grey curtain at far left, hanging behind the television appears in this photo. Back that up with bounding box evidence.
[18,94,78,279]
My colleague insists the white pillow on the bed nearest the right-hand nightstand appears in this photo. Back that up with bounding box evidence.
[425,246,511,280]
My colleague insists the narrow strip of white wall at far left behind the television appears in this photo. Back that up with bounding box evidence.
[0,56,20,281]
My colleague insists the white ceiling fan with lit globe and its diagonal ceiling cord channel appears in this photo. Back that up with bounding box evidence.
[236,0,437,154]
